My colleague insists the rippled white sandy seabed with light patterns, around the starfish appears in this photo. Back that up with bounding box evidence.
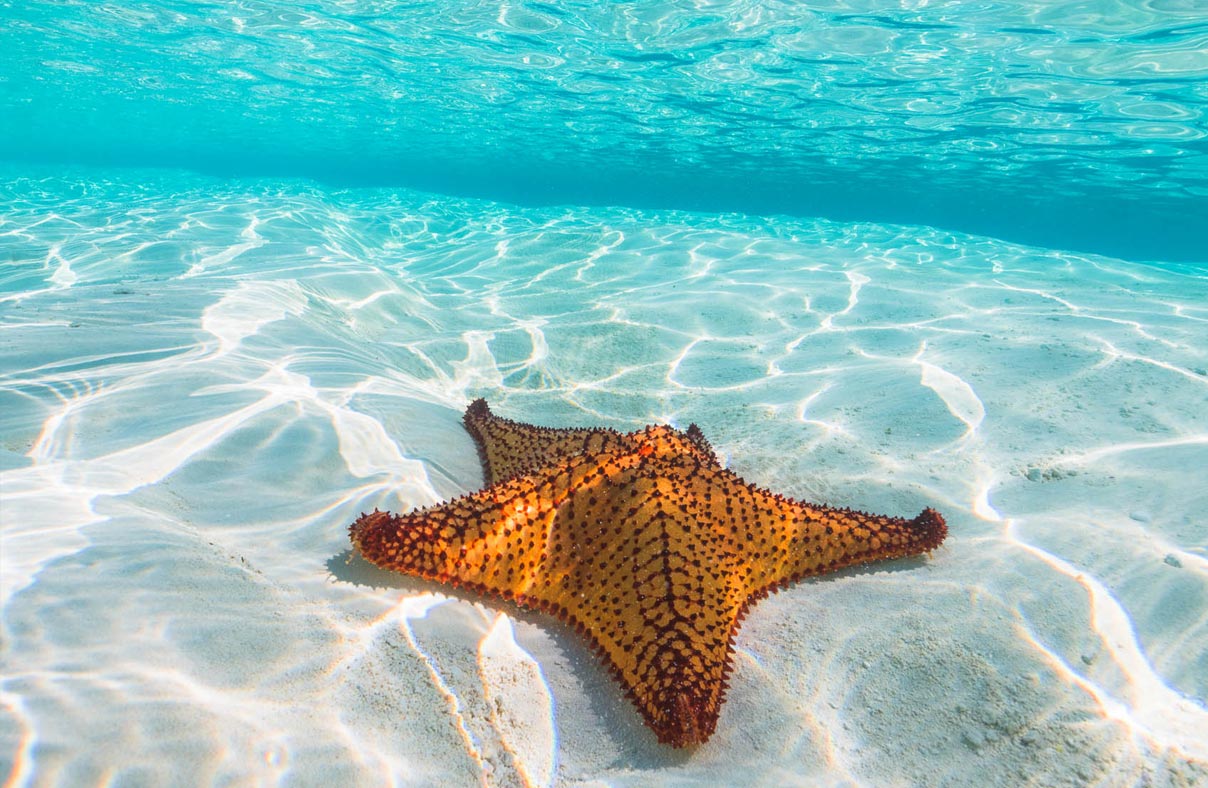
[0,167,1208,786]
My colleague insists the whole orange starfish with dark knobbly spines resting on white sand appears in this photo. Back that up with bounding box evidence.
[349,399,947,747]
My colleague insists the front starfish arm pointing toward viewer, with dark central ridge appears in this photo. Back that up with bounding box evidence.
[532,464,745,747]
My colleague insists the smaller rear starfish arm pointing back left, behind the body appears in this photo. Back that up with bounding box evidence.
[464,399,633,485]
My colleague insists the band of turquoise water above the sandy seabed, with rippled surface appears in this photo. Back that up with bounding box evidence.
[0,0,1208,262]
